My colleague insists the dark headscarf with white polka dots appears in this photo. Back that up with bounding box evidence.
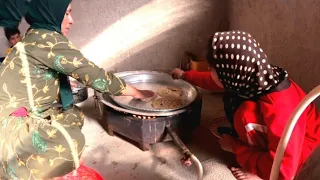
[209,31,288,98]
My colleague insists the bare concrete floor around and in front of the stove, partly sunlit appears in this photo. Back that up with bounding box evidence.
[80,92,235,180]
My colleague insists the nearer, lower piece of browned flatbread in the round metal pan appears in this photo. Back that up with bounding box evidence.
[151,97,183,109]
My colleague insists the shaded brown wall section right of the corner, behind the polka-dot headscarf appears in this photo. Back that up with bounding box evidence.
[228,0,320,94]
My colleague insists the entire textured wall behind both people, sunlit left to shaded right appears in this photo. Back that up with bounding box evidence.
[0,0,320,103]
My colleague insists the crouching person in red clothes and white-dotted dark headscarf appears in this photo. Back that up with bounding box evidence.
[172,31,320,179]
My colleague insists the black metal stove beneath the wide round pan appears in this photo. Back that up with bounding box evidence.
[98,96,202,151]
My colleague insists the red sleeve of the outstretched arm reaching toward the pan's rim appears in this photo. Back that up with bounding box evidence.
[183,70,224,92]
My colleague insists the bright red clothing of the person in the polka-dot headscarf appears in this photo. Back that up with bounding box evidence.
[185,72,320,180]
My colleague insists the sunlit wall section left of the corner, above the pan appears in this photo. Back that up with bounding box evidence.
[70,0,227,71]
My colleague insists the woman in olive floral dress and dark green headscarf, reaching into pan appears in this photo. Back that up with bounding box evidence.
[0,0,153,180]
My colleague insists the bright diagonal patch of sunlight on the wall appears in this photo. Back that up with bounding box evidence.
[81,0,208,68]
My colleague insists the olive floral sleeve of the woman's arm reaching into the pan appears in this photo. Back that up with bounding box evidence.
[37,33,125,95]
